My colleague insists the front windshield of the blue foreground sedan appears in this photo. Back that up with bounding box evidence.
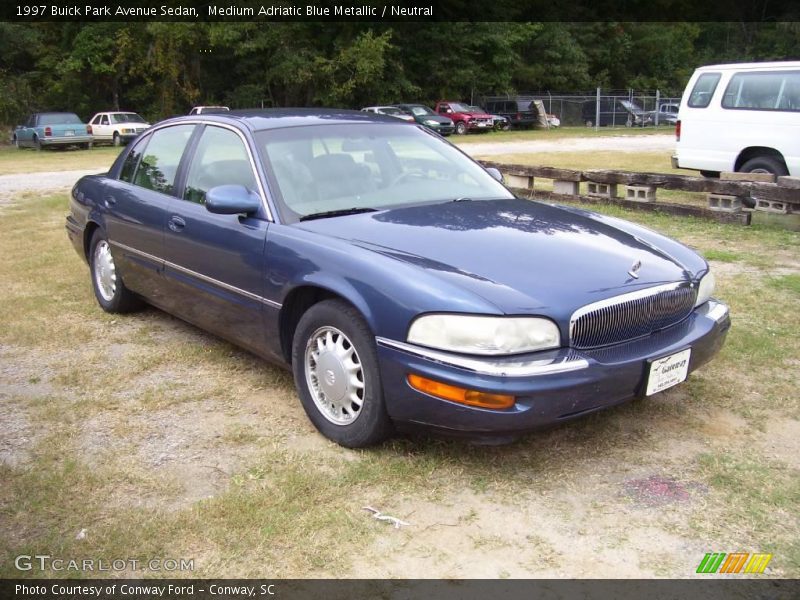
[256,123,513,222]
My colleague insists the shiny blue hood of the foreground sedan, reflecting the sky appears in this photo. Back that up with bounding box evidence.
[298,199,705,319]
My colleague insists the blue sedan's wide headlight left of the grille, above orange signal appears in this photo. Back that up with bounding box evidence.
[408,315,561,355]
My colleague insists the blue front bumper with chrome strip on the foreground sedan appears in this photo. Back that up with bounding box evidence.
[378,300,730,435]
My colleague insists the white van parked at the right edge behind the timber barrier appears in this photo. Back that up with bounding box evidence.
[672,61,800,177]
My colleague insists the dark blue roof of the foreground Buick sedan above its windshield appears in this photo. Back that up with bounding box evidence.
[159,108,404,131]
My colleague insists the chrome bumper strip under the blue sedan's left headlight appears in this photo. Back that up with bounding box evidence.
[375,337,589,377]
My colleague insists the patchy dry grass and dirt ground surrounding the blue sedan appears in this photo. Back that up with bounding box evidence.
[0,178,800,578]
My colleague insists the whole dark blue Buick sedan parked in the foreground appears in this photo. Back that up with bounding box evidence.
[67,109,730,447]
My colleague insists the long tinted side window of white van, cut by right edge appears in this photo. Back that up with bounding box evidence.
[722,71,800,112]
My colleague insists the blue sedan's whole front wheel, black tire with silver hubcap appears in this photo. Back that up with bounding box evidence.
[292,300,393,448]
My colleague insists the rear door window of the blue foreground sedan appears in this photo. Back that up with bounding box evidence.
[133,125,195,195]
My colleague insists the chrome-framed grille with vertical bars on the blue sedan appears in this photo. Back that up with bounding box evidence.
[569,283,697,349]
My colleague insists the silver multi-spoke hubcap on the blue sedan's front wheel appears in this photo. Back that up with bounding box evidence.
[305,326,364,425]
